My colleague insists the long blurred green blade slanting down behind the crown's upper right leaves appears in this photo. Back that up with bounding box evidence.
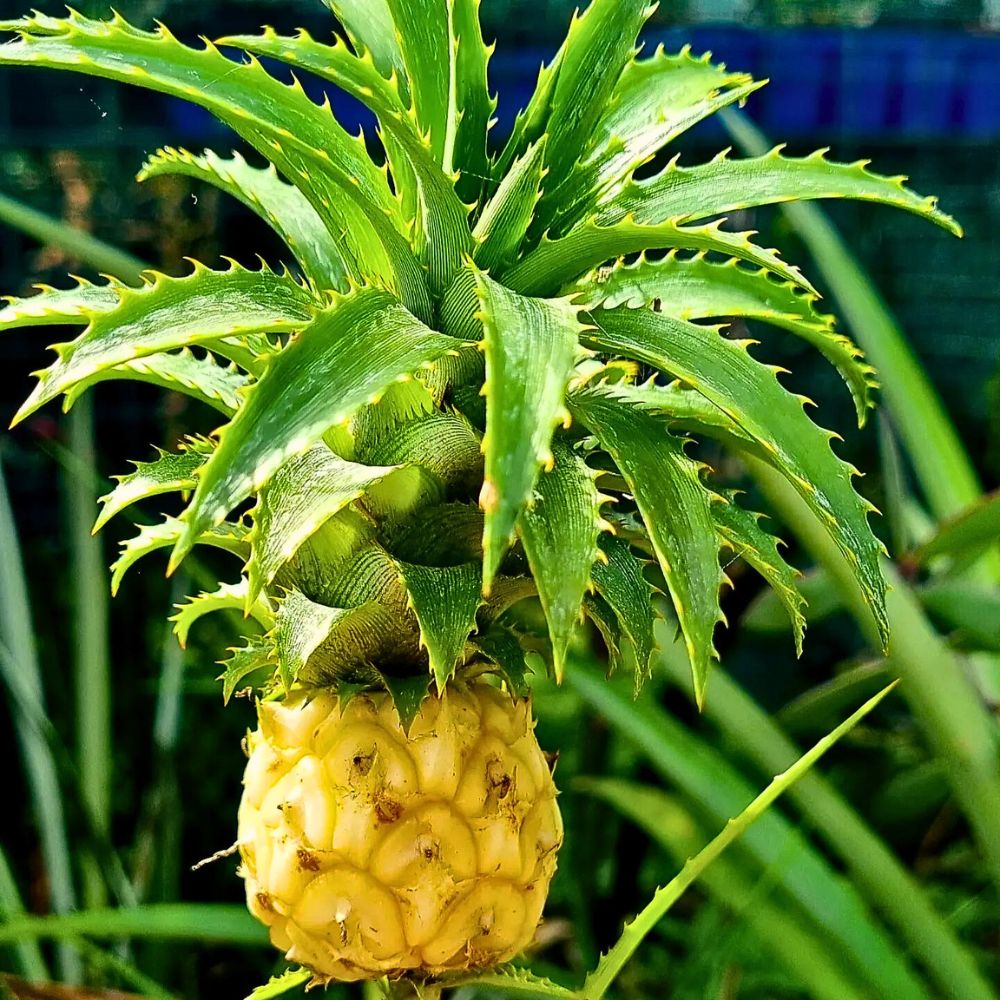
[720,109,988,567]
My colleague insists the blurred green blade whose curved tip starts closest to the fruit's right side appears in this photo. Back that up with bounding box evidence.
[576,780,865,1000]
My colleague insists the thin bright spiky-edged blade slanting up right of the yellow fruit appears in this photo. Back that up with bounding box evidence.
[581,684,900,1000]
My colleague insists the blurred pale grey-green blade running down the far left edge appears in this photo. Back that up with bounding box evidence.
[0,465,83,983]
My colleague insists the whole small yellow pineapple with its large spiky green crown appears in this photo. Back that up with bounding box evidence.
[0,0,958,982]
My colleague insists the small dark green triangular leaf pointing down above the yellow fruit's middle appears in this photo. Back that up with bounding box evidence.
[397,562,481,694]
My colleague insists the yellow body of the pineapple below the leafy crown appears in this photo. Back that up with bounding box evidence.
[238,681,563,982]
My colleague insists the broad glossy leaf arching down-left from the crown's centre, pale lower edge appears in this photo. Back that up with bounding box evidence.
[172,287,463,566]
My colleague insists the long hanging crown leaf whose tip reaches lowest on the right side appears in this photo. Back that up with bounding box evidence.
[569,385,725,704]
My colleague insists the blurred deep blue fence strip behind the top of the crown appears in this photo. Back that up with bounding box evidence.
[154,26,1000,142]
